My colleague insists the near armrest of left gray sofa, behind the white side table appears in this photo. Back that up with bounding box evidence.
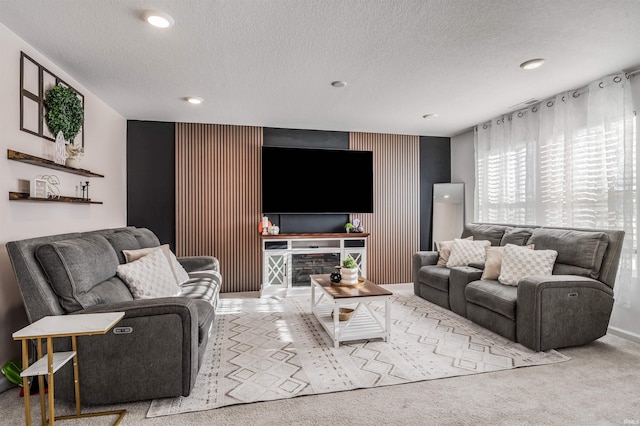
[56,297,198,404]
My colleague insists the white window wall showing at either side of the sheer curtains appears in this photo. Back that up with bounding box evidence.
[451,74,640,342]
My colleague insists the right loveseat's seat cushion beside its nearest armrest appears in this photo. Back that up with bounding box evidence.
[464,280,518,321]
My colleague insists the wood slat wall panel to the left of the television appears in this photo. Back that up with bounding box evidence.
[175,123,262,293]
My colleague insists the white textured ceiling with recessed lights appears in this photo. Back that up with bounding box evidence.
[0,0,640,136]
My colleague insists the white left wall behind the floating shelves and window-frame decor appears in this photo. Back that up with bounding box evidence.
[0,24,127,364]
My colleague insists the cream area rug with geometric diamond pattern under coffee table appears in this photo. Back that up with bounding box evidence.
[147,286,570,417]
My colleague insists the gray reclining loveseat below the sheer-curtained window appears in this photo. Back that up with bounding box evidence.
[412,223,624,351]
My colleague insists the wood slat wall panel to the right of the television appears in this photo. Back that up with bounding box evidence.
[349,132,420,284]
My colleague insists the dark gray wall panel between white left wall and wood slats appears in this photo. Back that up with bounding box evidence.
[127,120,176,253]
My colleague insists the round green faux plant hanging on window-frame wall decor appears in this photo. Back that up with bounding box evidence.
[44,86,84,142]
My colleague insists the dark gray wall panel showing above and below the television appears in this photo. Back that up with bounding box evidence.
[262,127,349,234]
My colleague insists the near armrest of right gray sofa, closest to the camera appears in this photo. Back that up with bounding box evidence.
[516,275,613,351]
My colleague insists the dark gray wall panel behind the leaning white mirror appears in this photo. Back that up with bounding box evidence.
[420,136,451,250]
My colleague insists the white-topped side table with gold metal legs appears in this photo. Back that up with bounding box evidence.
[13,312,127,426]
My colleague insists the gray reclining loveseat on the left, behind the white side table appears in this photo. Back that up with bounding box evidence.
[7,227,221,404]
